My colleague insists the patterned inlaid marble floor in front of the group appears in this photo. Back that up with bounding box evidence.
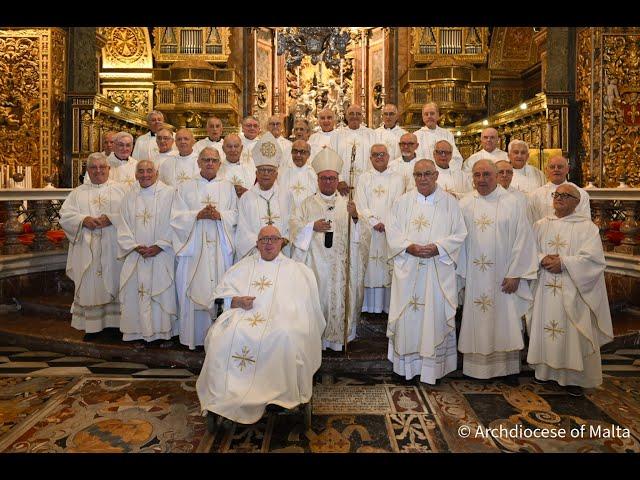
[0,346,640,453]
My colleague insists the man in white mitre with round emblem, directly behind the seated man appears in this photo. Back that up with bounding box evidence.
[235,132,293,260]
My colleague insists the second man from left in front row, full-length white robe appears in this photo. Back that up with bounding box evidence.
[118,160,178,342]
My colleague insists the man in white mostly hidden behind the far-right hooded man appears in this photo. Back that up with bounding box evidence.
[529,156,591,225]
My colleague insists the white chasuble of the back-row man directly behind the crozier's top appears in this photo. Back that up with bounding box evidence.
[330,126,376,188]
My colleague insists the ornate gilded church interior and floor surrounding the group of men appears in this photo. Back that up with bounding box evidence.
[0,26,640,453]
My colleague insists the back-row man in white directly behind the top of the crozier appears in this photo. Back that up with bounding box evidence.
[331,105,376,196]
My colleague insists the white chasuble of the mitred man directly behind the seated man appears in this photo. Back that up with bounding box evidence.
[236,183,293,260]
